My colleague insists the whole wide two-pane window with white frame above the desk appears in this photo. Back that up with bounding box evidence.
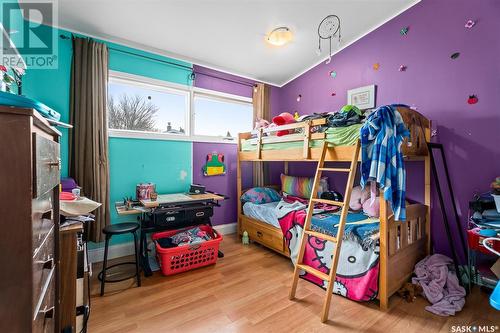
[108,72,253,142]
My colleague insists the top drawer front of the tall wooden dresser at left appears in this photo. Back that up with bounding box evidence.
[33,133,61,198]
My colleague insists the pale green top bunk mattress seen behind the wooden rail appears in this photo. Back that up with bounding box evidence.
[241,124,363,151]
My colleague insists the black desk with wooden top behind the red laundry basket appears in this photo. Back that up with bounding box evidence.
[115,193,227,276]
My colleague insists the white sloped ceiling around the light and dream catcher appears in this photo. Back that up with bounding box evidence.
[43,0,419,86]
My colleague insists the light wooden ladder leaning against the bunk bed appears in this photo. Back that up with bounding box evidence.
[290,141,360,322]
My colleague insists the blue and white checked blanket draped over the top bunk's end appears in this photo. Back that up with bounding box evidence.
[360,105,410,221]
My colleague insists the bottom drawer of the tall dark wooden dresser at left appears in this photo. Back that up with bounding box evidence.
[32,268,56,333]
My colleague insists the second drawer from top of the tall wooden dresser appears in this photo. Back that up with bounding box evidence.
[31,192,54,254]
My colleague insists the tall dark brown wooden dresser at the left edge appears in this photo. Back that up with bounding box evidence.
[0,106,60,333]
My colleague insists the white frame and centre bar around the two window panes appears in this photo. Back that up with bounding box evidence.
[108,71,252,144]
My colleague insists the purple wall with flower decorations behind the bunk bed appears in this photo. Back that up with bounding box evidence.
[273,0,500,253]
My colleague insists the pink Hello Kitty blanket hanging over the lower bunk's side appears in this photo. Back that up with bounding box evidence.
[276,200,379,301]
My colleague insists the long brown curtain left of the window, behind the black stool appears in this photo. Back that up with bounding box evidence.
[69,38,110,242]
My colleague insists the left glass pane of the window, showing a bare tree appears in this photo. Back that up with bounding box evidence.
[108,78,189,135]
